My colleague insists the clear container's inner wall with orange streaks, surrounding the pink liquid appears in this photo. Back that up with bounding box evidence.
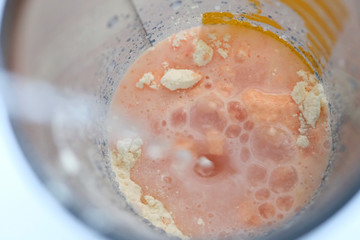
[1,0,360,239]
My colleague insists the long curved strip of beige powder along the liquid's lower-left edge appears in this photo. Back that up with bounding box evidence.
[112,138,189,239]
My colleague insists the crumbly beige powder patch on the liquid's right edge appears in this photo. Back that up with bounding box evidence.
[291,70,327,148]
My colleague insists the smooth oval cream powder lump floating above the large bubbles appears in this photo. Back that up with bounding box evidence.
[161,68,202,91]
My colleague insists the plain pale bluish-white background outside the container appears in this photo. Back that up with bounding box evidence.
[0,0,360,240]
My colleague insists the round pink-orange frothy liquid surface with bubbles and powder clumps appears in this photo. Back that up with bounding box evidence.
[109,25,331,239]
